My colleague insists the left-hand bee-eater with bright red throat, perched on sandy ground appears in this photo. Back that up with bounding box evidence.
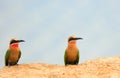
[5,38,25,66]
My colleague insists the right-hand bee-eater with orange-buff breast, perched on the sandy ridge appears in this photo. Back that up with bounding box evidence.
[64,36,83,66]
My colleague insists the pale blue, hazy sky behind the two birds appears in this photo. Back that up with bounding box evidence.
[0,0,120,68]
